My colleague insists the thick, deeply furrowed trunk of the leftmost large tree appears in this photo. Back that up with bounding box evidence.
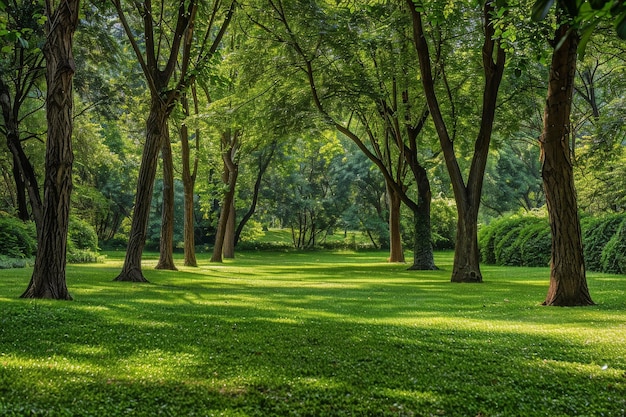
[22,0,79,300]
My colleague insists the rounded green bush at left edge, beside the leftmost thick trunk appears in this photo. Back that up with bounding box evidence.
[0,216,37,259]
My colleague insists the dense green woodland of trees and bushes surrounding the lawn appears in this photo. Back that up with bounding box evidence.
[0,0,626,306]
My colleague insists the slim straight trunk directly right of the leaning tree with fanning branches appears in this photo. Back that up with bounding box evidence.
[156,129,177,271]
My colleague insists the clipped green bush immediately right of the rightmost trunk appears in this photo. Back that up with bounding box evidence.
[581,214,626,271]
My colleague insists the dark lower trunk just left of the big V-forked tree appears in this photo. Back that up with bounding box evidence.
[409,165,438,271]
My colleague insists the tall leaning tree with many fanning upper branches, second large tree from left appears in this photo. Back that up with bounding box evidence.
[112,0,234,282]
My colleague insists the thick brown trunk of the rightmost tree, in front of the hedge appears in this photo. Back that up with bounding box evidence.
[539,24,594,306]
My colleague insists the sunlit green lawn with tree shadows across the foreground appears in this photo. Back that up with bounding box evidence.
[0,251,626,417]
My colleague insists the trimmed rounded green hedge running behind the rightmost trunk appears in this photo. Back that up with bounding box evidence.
[478,214,626,274]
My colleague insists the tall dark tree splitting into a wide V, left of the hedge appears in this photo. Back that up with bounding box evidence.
[406,0,505,282]
